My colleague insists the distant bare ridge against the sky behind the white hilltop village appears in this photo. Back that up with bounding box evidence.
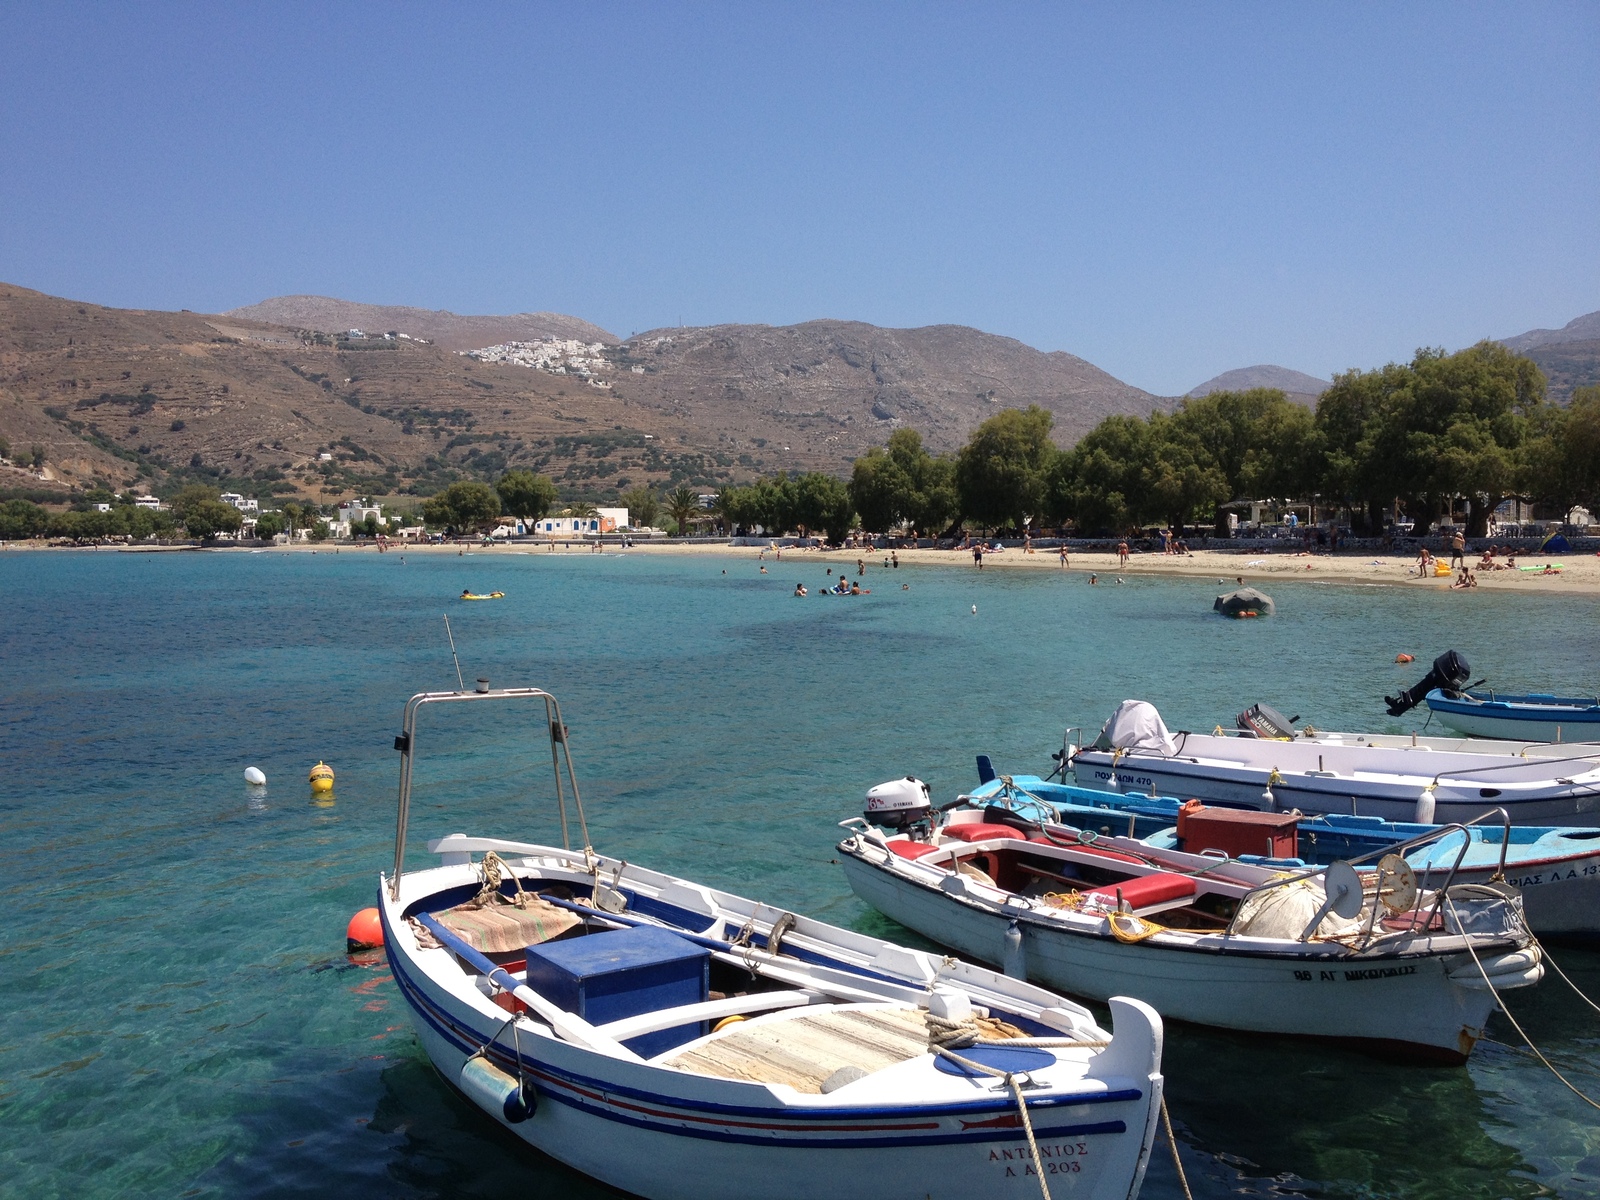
[222,296,618,350]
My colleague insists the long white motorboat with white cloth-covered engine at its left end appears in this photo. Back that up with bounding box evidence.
[1070,701,1600,826]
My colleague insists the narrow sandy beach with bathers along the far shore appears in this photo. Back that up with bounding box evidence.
[0,541,1600,595]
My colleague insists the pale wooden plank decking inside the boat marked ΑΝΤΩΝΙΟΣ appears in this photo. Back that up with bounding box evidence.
[661,1005,928,1094]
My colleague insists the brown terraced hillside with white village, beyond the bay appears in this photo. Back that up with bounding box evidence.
[0,283,1163,499]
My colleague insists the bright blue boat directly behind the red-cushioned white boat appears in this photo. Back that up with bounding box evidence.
[970,774,1600,942]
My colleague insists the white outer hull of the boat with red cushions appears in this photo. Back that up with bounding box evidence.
[842,853,1494,1064]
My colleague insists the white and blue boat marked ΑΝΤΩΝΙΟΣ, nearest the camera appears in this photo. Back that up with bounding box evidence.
[379,685,1162,1200]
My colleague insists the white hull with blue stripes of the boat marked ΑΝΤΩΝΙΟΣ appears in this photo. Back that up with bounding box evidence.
[381,876,1162,1200]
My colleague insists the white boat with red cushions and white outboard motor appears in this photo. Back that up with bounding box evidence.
[838,779,1544,1062]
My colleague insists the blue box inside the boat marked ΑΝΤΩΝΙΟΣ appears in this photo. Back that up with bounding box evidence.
[528,925,710,1058]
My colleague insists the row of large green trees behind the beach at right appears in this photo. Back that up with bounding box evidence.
[850,342,1600,536]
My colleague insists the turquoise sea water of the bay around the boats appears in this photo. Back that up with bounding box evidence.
[0,550,1600,1200]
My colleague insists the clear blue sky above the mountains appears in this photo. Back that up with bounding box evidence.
[0,0,1600,394]
